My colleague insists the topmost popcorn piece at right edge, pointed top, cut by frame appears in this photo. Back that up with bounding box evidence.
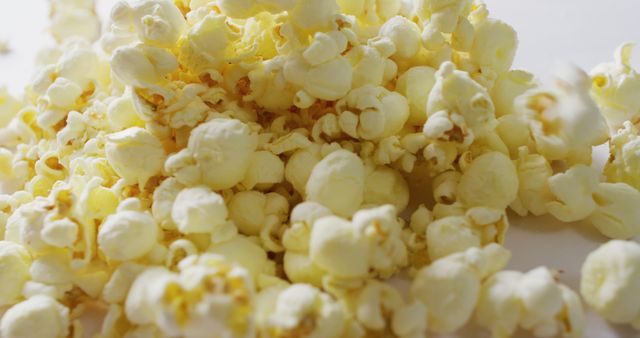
[589,43,640,133]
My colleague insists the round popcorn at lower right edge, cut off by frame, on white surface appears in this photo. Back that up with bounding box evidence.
[580,240,640,330]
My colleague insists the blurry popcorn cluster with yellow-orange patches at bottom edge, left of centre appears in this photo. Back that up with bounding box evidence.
[125,254,254,337]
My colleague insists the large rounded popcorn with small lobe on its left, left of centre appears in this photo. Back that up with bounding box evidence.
[165,118,258,190]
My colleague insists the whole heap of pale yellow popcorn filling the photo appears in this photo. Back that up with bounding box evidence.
[0,0,640,338]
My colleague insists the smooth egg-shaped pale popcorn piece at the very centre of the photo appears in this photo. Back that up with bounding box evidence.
[305,150,365,217]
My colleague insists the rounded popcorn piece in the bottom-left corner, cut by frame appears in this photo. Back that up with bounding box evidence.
[0,296,69,338]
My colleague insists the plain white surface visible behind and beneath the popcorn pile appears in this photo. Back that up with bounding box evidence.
[0,0,640,338]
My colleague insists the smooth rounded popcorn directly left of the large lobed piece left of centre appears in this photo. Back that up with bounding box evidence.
[105,127,166,188]
